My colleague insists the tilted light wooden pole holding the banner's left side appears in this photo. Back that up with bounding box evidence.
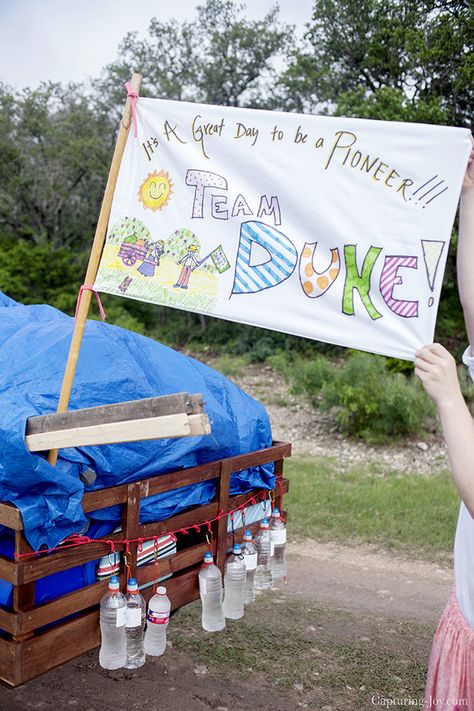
[48,74,142,466]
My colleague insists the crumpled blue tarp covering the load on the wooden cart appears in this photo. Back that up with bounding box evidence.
[0,292,274,550]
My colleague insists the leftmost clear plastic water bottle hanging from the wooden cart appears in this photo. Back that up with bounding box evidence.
[99,575,127,669]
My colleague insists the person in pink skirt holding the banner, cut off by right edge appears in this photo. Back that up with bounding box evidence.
[415,136,474,711]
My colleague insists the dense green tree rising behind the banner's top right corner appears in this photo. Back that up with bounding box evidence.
[282,0,474,126]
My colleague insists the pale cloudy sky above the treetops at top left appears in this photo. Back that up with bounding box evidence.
[0,0,313,88]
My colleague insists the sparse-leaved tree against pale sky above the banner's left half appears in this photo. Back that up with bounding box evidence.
[97,0,293,107]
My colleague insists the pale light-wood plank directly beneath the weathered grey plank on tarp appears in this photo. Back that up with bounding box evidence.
[25,414,211,452]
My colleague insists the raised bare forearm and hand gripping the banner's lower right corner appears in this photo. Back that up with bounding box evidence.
[415,341,474,518]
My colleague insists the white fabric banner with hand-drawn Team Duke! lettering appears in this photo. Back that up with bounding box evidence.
[95,98,470,360]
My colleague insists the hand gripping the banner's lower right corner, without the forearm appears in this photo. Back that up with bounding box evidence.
[415,343,462,408]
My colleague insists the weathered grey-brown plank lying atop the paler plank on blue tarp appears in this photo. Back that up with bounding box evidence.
[26,393,203,435]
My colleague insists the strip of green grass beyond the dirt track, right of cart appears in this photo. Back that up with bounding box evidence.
[285,458,459,563]
